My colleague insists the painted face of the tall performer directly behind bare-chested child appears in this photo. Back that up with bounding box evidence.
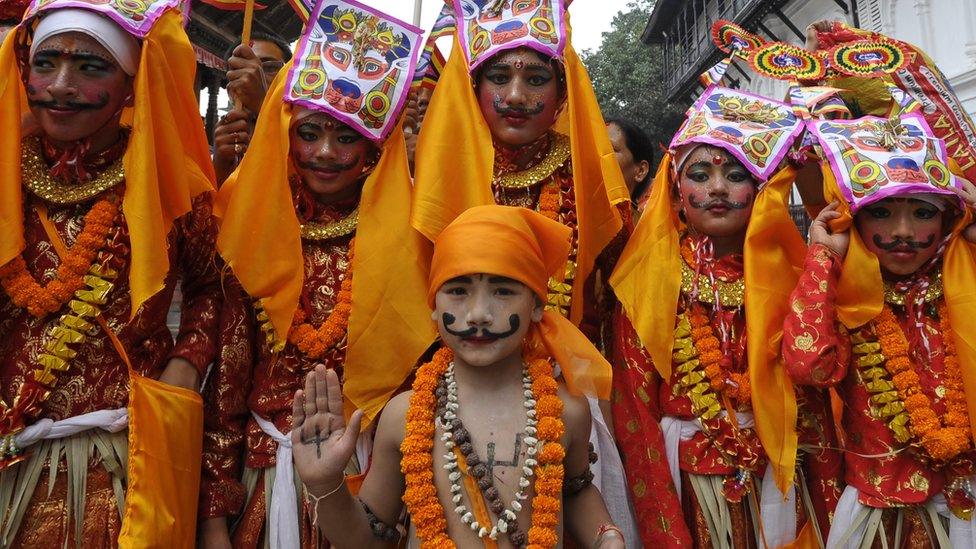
[476,48,564,147]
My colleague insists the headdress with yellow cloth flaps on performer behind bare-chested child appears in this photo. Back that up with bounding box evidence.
[412,0,630,323]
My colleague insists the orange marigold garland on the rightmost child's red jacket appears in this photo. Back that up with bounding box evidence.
[875,301,971,462]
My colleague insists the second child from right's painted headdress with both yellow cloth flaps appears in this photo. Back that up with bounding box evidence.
[610,21,808,493]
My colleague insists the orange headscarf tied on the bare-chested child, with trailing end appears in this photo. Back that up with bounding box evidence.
[427,205,611,399]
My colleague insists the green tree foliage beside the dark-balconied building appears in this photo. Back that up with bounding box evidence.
[580,0,684,165]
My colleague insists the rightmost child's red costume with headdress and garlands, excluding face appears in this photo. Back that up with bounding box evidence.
[782,24,976,548]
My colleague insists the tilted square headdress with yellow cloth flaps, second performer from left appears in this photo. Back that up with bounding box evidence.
[217,0,434,419]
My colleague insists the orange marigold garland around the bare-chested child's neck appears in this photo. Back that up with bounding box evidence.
[400,347,565,549]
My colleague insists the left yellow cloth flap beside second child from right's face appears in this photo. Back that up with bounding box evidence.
[610,154,681,379]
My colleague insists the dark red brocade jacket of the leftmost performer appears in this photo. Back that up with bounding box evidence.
[0,192,222,422]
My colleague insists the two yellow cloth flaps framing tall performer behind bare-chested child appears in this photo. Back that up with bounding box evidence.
[412,26,629,324]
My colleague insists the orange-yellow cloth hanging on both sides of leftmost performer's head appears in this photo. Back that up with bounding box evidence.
[0,10,214,316]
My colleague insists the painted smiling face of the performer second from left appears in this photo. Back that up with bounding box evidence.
[288,113,377,204]
